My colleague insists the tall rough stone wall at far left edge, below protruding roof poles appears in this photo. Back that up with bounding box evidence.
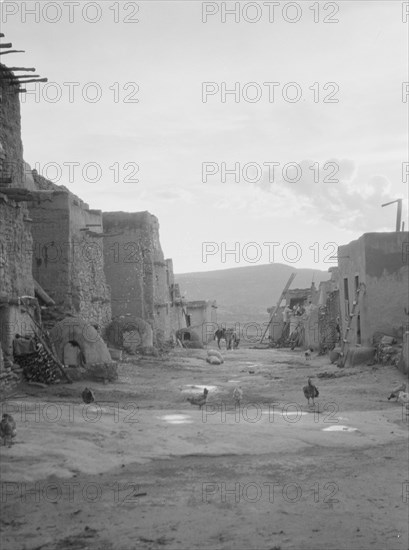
[0,64,38,389]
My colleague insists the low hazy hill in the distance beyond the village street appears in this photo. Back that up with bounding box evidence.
[175,263,330,324]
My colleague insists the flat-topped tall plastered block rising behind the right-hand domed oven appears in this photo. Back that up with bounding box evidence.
[103,212,172,343]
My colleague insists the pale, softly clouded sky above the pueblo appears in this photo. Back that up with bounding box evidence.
[0,0,409,273]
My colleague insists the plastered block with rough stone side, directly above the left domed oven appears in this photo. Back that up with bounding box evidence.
[30,189,111,328]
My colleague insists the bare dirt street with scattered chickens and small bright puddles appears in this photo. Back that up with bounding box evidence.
[0,350,409,550]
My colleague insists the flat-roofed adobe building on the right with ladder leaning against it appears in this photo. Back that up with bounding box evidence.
[338,231,409,346]
